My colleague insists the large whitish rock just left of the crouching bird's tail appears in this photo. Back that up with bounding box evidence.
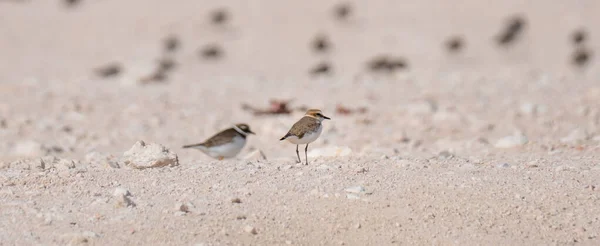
[121,141,179,169]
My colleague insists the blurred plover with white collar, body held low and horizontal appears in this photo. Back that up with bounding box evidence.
[183,124,255,160]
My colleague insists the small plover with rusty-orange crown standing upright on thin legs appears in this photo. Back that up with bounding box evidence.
[279,109,331,165]
